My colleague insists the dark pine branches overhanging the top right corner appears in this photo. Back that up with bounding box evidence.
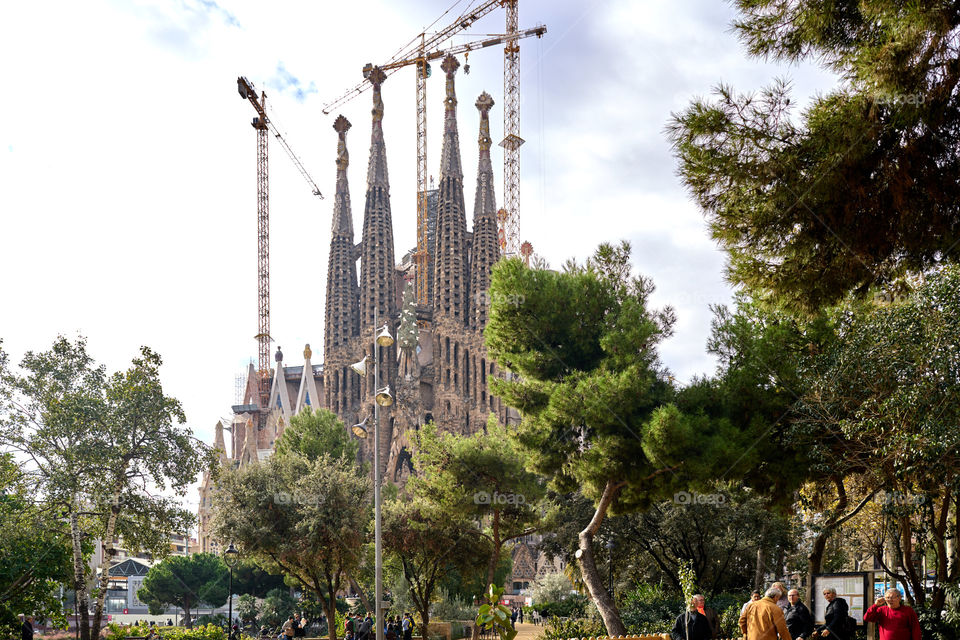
[669,0,960,311]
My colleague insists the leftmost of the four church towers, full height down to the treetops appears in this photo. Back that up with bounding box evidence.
[323,116,360,414]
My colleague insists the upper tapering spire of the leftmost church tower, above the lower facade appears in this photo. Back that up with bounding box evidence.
[323,116,360,362]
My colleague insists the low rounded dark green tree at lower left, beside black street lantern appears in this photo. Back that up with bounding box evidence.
[137,553,228,626]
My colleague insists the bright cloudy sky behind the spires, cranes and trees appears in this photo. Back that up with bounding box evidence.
[0,0,836,508]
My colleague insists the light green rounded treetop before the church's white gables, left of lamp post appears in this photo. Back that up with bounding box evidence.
[276,407,360,462]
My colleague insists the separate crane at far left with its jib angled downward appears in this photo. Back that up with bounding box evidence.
[237,76,323,420]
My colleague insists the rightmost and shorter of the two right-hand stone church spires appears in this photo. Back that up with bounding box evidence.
[470,91,500,330]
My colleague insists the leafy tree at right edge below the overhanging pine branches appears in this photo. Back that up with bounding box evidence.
[792,266,960,612]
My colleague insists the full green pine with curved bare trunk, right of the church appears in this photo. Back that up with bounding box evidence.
[485,243,742,635]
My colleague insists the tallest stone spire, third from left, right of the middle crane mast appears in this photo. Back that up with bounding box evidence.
[433,55,469,324]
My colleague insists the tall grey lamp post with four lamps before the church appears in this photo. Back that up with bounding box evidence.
[350,309,393,640]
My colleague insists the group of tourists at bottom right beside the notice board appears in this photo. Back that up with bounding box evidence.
[670,582,920,640]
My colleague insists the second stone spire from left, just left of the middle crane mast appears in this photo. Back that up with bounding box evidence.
[360,67,397,335]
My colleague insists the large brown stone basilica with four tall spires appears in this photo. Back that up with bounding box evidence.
[199,56,553,588]
